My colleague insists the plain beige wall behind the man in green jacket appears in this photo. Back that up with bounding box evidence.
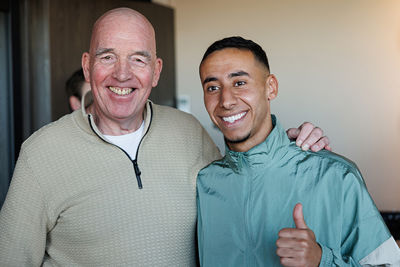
[158,0,400,210]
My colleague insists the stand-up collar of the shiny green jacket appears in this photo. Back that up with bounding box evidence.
[224,115,290,172]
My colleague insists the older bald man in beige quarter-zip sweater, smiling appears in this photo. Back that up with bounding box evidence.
[0,8,326,267]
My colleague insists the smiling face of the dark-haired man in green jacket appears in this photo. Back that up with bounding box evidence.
[200,48,278,152]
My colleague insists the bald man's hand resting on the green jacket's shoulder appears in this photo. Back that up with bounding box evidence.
[286,122,332,152]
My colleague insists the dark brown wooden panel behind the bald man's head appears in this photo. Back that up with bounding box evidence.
[50,0,175,120]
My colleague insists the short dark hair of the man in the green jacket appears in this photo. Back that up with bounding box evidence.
[200,36,270,71]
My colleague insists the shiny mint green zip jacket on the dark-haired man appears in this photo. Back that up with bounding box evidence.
[197,116,400,267]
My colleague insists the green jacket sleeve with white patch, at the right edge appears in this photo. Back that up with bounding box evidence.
[320,169,400,267]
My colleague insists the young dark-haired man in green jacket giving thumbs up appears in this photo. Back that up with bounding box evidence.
[197,37,400,266]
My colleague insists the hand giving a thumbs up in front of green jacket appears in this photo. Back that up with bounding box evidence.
[276,203,322,267]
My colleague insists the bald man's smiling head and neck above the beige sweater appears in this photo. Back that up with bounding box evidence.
[82,8,162,135]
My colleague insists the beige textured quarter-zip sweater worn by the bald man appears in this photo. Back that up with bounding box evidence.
[0,99,220,266]
